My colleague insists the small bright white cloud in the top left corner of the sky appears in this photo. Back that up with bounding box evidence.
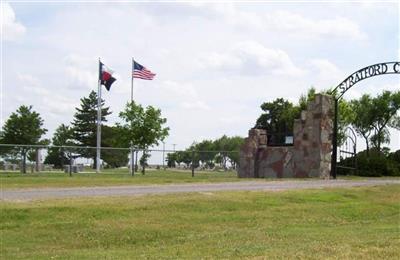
[1,2,26,41]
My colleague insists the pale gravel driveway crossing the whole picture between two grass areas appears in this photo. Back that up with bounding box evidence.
[0,179,400,201]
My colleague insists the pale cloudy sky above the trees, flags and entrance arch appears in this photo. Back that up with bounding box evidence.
[0,1,400,150]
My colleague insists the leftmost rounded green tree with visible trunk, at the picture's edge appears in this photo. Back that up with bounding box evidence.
[1,106,47,173]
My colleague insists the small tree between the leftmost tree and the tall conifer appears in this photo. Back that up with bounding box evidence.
[44,124,74,168]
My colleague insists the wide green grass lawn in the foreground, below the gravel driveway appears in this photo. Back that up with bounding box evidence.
[0,185,400,259]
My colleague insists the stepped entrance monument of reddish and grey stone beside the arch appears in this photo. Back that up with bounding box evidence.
[238,94,334,179]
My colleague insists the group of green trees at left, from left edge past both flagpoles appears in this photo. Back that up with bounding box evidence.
[0,91,169,172]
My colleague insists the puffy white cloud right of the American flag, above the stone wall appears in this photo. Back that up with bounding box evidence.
[198,41,304,76]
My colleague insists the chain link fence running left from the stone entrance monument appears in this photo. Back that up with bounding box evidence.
[0,144,239,176]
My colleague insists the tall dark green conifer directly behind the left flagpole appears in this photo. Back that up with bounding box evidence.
[72,91,111,168]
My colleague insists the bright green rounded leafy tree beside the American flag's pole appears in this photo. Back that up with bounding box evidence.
[117,101,169,174]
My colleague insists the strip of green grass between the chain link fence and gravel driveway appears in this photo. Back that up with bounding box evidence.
[0,169,244,189]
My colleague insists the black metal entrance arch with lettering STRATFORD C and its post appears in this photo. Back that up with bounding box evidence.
[331,61,400,179]
